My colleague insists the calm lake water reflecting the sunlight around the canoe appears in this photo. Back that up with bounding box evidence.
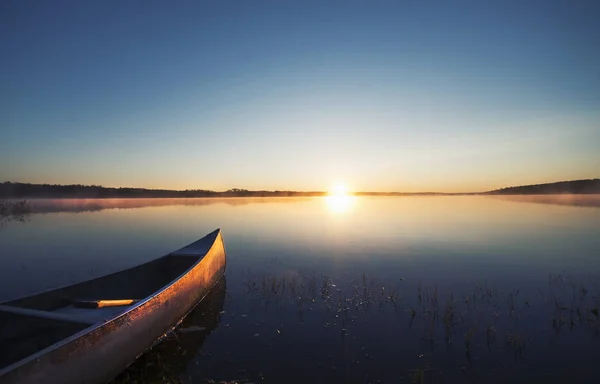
[0,196,600,383]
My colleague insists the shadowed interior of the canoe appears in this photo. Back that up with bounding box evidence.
[0,254,204,369]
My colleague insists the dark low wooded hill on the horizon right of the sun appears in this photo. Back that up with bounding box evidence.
[486,179,600,195]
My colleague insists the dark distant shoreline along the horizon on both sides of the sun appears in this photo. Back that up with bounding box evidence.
[0,179,600,199]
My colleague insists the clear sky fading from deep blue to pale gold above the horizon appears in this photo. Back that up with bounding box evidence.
[0,0,600,192]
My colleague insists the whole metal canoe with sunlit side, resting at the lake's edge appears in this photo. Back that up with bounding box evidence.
[0,229,226,384]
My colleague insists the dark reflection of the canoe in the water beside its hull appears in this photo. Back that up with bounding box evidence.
[111,276,227,384]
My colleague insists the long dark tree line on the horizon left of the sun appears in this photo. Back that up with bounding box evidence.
[0,181,325,198]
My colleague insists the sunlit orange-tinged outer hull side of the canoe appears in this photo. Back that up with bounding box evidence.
[0,230,226,384]
